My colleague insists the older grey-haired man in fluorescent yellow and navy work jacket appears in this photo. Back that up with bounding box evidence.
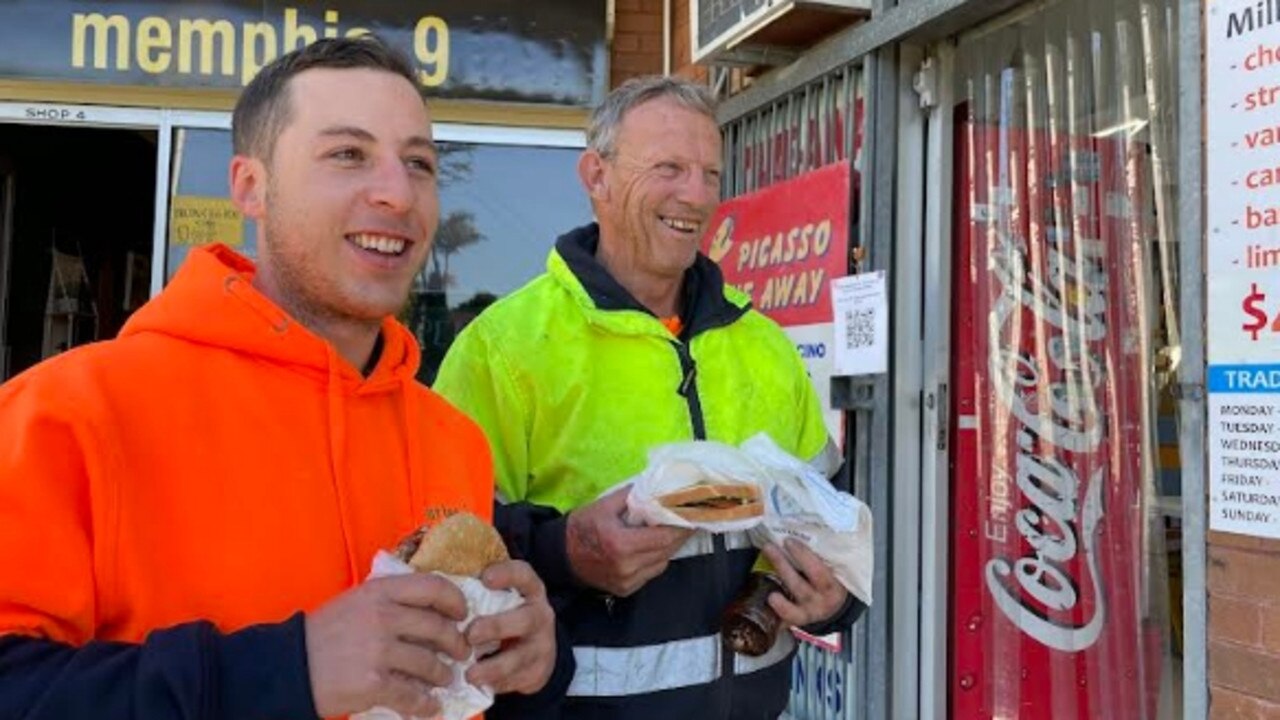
[435,77,861,720]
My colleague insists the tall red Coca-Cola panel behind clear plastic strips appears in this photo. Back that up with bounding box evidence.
[951,123,1166,720]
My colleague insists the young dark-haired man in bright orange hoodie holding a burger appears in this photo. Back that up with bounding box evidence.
[0,38,572,719]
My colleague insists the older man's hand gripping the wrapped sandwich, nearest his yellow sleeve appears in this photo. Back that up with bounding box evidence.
[564,487,694,597]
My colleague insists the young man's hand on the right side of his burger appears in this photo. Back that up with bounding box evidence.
[467,560,556,694]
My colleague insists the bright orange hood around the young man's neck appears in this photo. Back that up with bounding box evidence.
[120,245,421,392]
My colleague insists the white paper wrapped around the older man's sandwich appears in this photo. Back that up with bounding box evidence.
[627,441,768,533]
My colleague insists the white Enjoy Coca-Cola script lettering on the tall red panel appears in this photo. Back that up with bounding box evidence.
[984,224,1107,652]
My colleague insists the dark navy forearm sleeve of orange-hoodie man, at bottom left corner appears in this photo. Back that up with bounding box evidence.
[0,612,316,720]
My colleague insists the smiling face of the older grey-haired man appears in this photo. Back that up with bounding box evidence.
[580,97,721,283]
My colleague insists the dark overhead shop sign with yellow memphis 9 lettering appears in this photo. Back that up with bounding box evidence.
[0,0,608,106]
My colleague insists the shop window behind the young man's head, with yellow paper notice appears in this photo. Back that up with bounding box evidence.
[158,128,591,383]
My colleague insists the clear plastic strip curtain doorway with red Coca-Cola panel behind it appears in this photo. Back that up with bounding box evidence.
[950,0,1181,720]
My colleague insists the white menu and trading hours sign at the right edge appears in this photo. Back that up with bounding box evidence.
[1204,0,1280,538]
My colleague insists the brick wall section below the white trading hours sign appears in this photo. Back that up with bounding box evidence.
[1208,533,1280,720]
